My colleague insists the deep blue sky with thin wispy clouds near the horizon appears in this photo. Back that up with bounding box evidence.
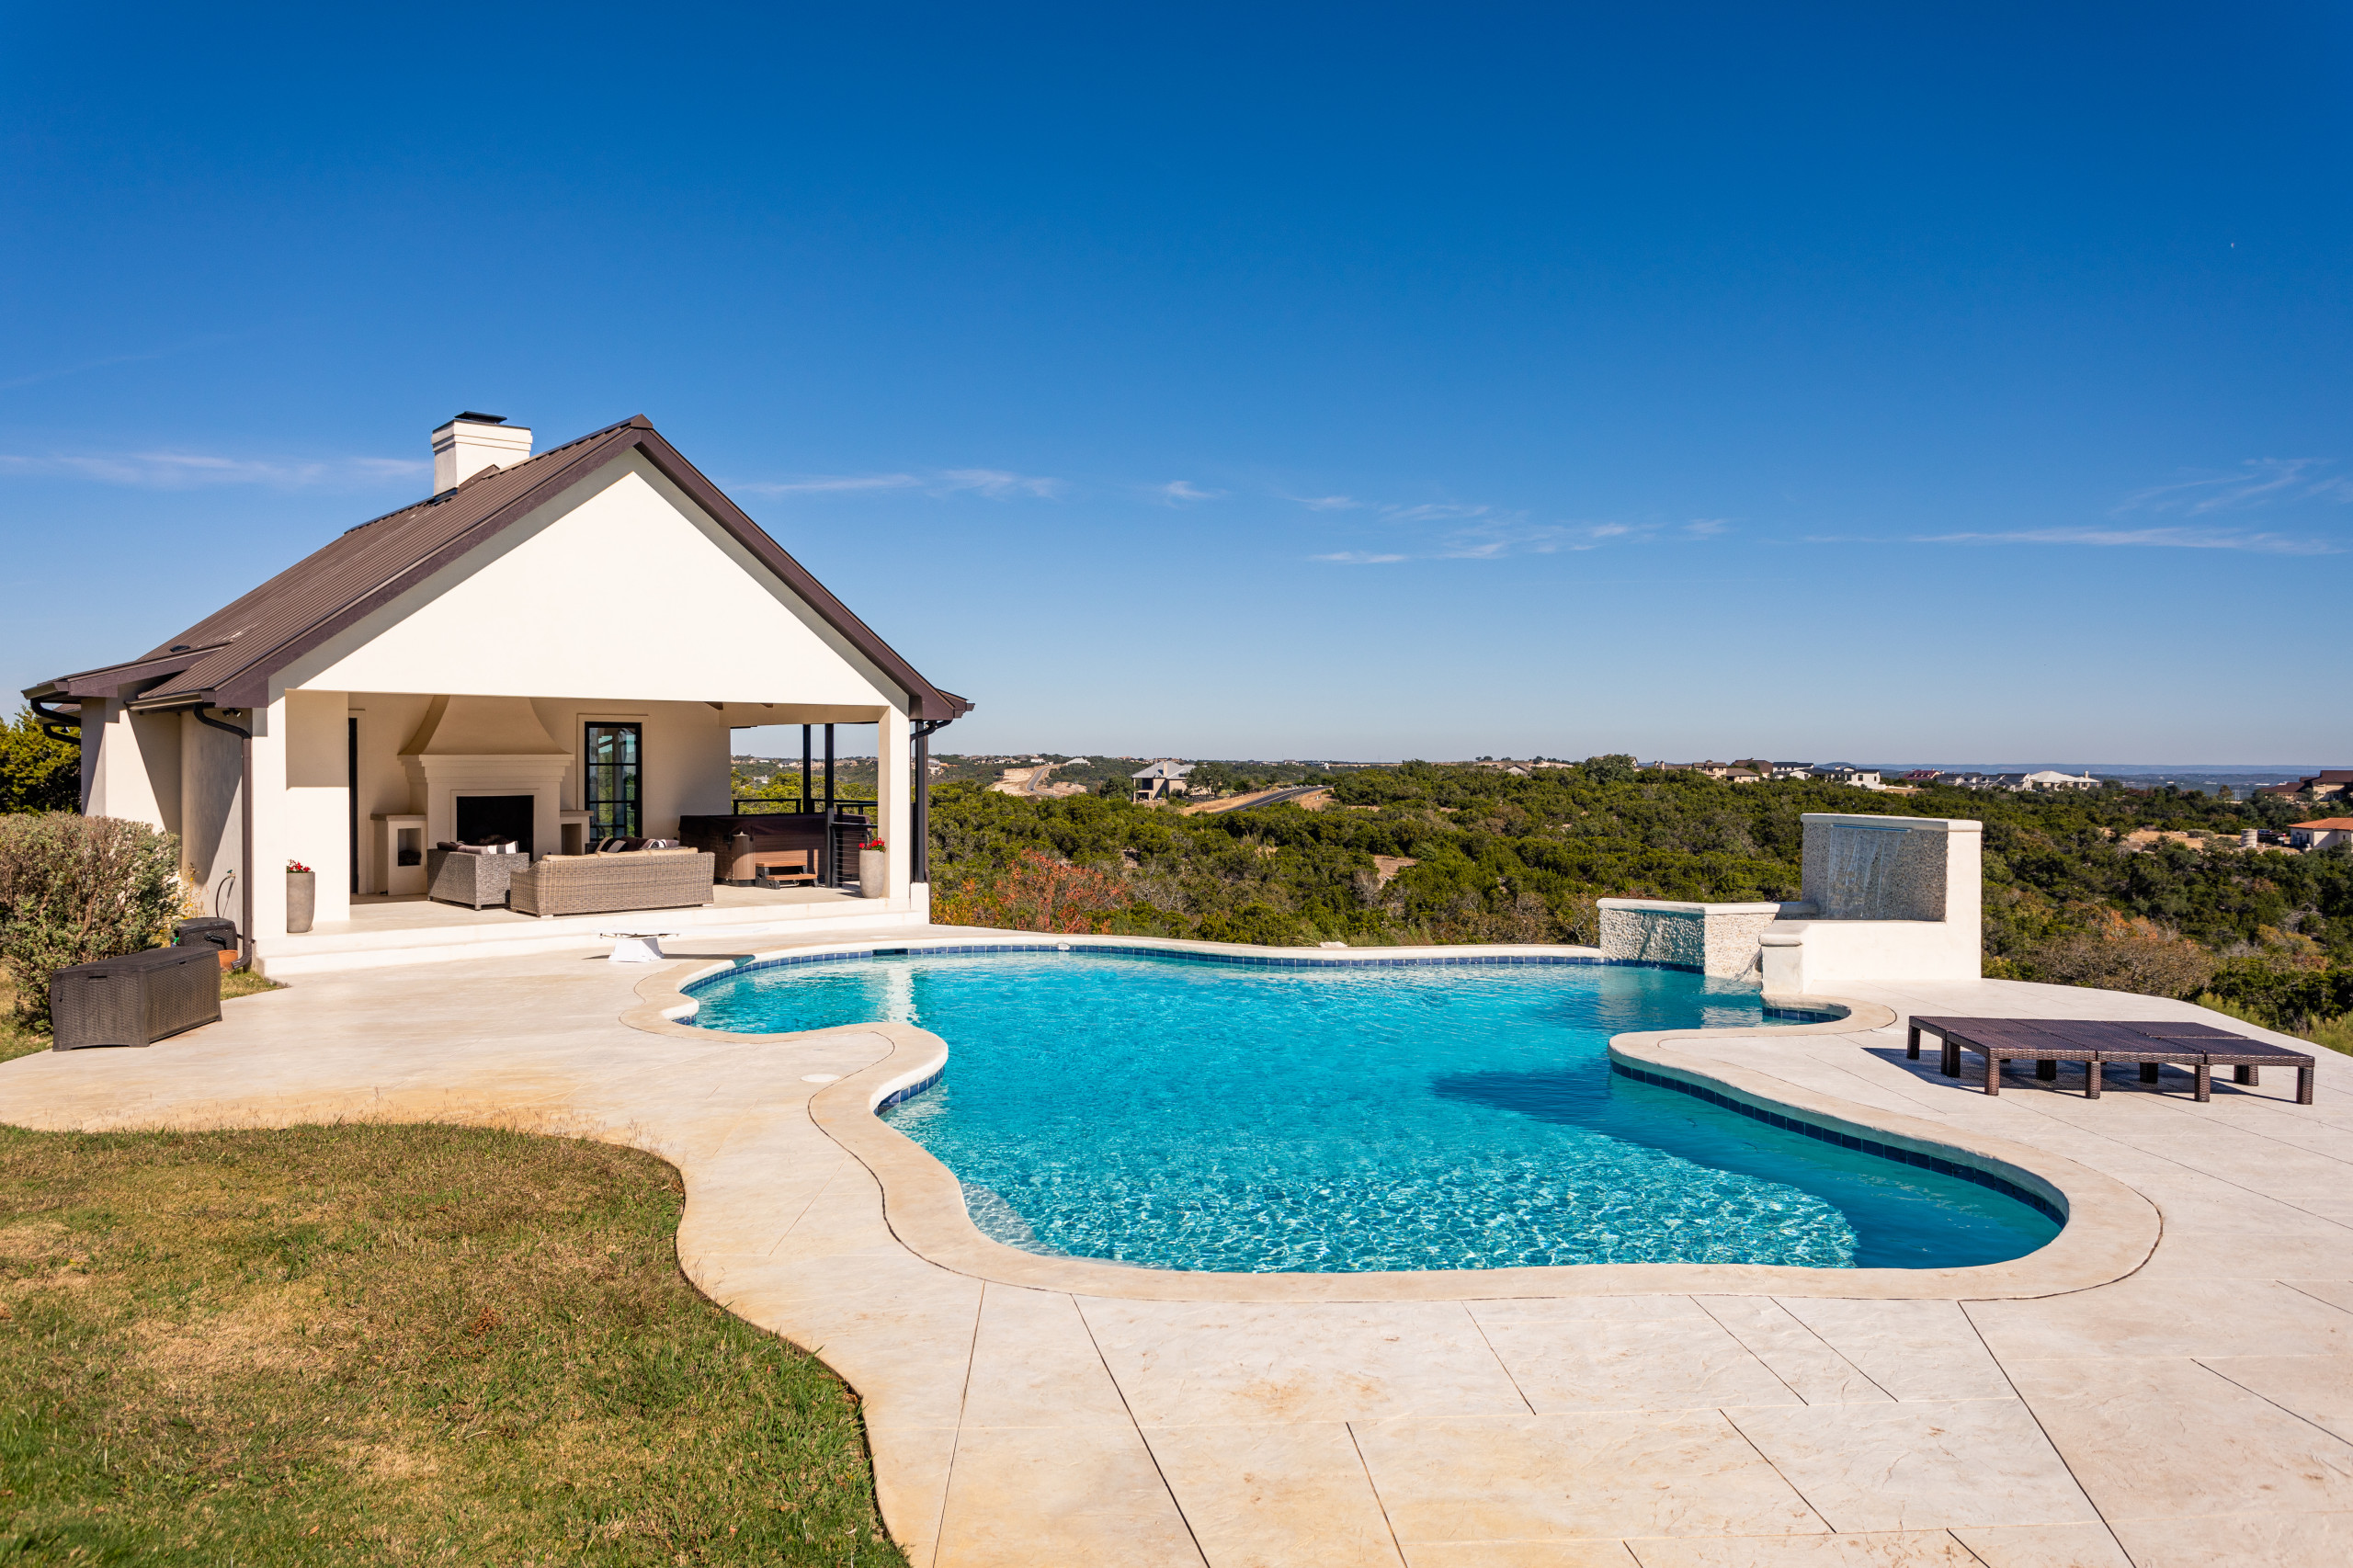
[0,5,2353,763]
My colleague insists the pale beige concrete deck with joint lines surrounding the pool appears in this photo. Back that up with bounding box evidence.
[0,930,2353,1568]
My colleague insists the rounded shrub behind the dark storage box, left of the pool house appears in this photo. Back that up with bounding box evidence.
[0,812,181,1027]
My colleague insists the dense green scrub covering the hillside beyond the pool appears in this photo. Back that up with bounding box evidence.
[932,756,2353,1027]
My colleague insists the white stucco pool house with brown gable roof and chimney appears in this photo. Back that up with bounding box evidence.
[26,415,972,970]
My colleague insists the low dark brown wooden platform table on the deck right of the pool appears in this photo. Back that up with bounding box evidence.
[1904,1017,2313,1104]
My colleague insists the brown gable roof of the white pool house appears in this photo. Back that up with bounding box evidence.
[24,415,972,721]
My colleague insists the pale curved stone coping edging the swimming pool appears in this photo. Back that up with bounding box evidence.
[621,932,2163,1304]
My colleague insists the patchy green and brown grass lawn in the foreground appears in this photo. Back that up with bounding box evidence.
[0,1125,904,1568]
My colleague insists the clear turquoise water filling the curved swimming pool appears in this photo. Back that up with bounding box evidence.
[694,953,2059,1271]
